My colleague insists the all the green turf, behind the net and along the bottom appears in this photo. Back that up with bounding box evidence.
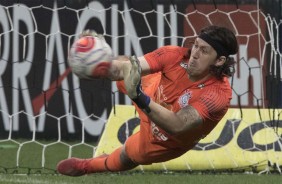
[0,140,282,184]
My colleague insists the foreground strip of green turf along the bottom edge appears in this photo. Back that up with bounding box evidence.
[0,172,281,184]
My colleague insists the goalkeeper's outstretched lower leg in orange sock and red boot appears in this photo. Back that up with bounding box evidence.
[57,147,137,176]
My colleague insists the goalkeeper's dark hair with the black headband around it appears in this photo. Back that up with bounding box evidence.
[200,26,238,79]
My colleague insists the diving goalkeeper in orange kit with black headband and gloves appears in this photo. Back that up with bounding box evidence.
[57,26,238,176]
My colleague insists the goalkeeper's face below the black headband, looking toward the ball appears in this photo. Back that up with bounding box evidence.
[187,38,221,81]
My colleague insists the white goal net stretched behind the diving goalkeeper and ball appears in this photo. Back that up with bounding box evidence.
[0,0,282,174]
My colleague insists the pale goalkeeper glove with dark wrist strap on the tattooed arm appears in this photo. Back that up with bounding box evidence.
[124,56,151,113]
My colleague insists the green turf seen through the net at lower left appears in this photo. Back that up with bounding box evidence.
[0,140,96,174]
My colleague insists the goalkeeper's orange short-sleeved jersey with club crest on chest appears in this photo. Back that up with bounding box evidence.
[117,46,232,150]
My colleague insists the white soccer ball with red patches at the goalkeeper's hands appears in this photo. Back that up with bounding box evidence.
[68,35,113,79]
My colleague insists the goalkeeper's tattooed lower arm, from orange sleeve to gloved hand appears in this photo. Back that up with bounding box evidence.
[124,56,203,135]
